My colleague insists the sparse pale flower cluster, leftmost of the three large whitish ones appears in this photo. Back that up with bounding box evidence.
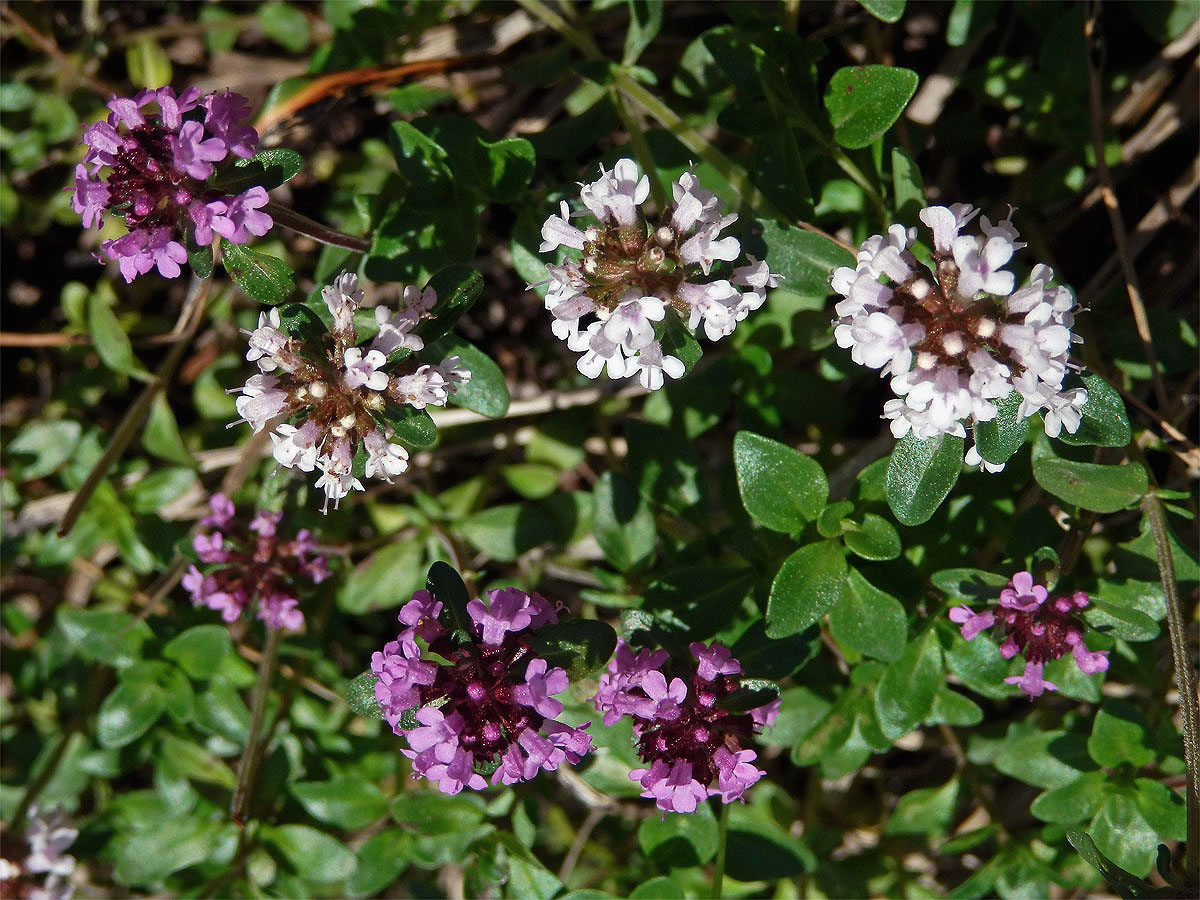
[229,272,470,510]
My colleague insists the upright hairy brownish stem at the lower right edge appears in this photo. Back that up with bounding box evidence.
[1141,491,1200,884]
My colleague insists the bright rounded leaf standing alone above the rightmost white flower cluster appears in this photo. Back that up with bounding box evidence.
[824,66,918,150]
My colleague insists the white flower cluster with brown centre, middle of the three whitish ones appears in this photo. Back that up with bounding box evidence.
[539,160,779,390]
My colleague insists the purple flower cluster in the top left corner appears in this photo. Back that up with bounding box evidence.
[72,88,271,281]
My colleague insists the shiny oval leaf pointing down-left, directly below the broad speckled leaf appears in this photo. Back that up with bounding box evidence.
[767,540,847,637]
